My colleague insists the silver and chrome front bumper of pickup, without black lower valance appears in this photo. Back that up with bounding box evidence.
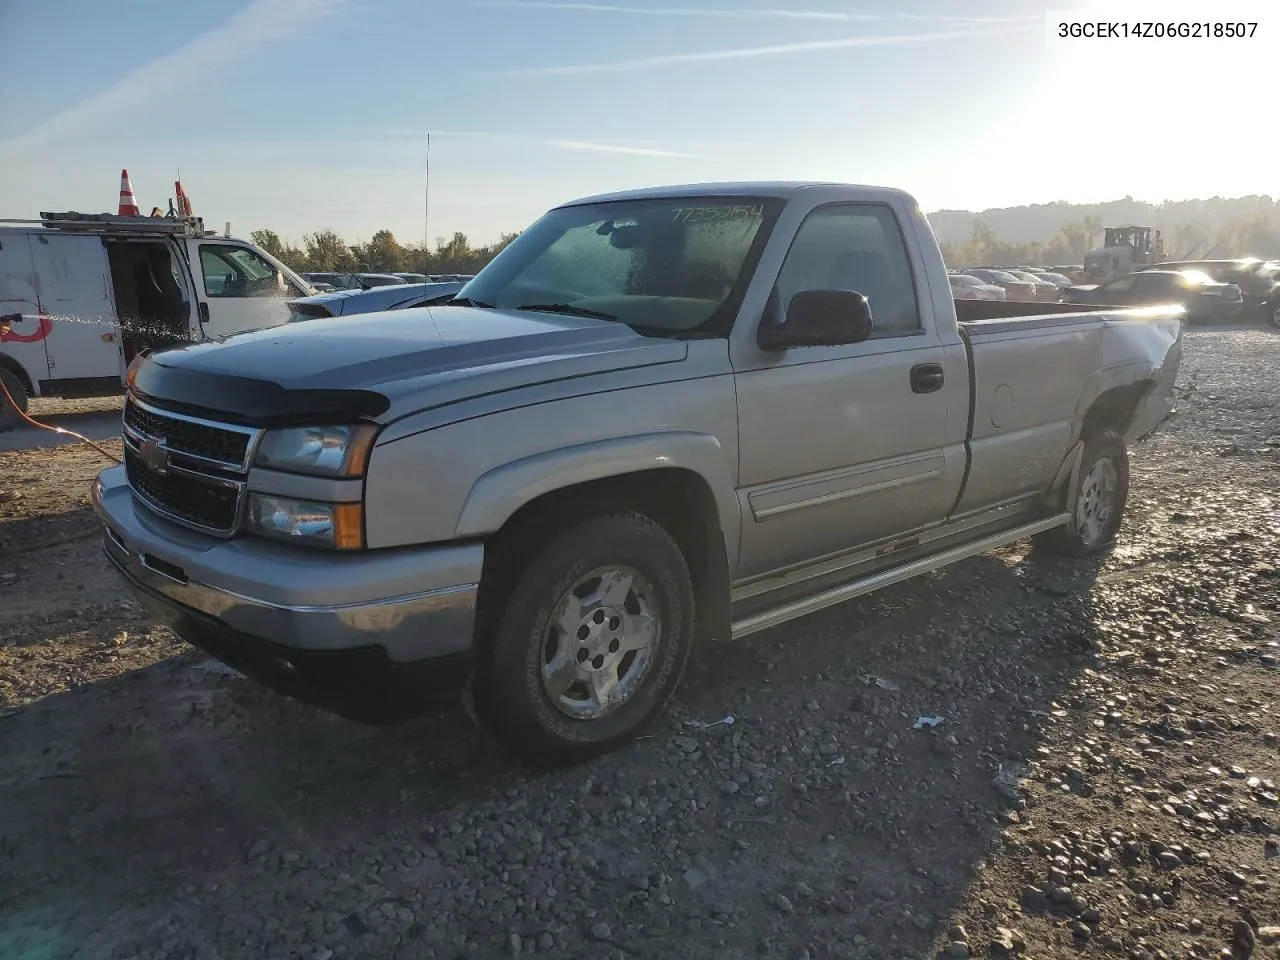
[92,467,484,664]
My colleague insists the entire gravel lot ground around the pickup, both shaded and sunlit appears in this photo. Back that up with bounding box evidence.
[0,330,1280,960]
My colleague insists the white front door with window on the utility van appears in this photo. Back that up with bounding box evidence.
[189,239,307,338]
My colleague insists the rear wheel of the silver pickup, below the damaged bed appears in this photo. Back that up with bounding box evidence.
[1036,429,1129,557]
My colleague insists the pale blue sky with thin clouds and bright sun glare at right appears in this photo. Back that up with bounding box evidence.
[0,0,1280,243]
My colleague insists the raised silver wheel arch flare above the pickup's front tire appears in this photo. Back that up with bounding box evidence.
[454,431,740,557]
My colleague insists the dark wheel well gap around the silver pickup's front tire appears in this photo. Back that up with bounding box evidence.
[477,467,730,640]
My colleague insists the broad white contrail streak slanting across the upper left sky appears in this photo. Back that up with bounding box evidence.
[0,0,347,147]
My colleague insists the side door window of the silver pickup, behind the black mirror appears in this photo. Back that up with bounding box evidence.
[777,204,922,335]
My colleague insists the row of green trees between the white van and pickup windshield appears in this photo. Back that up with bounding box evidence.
[250,229,520,274]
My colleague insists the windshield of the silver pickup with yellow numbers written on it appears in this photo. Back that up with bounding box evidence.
[461,197,780,334]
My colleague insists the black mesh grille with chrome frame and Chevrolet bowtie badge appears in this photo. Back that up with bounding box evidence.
[124,396,261,536]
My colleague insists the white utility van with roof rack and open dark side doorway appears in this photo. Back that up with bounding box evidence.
[0,212,315,430]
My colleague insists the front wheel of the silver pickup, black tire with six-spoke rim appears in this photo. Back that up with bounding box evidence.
[471,513,694,768]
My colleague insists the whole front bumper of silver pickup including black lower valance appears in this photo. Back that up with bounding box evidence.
[92,467,484,722]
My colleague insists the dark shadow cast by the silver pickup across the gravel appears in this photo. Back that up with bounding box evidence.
[0,552,1100,957]
